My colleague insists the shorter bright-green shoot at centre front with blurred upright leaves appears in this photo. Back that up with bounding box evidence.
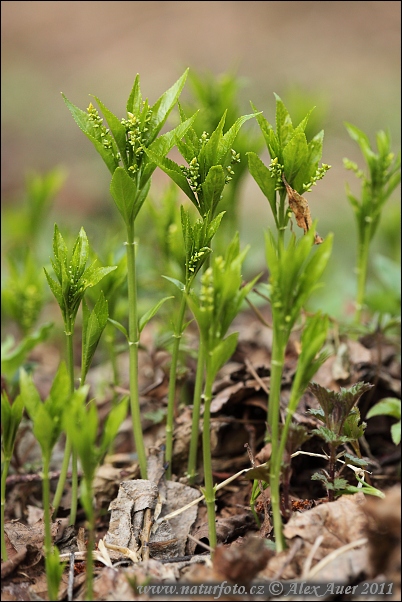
[188,234,258,549]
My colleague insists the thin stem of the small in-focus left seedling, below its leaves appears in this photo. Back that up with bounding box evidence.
[53,318,78,525]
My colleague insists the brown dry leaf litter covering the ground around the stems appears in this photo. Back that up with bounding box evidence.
[2,312,401,600]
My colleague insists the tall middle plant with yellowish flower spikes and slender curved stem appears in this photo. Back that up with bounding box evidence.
[147,105,254,480]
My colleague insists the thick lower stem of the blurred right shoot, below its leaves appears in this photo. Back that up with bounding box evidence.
[268,329,286,553]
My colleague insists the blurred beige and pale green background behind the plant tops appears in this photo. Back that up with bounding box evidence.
[1,1,401,316]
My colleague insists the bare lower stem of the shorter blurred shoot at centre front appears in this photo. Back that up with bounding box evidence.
[202,366,217,555]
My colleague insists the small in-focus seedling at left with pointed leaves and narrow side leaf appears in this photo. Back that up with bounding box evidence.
[45,225,116,524]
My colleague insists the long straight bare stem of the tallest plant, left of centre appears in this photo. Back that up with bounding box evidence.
[126,224,147,479]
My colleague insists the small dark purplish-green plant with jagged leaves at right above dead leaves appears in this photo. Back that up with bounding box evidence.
[308,382,373,502]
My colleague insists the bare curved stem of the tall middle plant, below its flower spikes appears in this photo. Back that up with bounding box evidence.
[166,291,186,479]
